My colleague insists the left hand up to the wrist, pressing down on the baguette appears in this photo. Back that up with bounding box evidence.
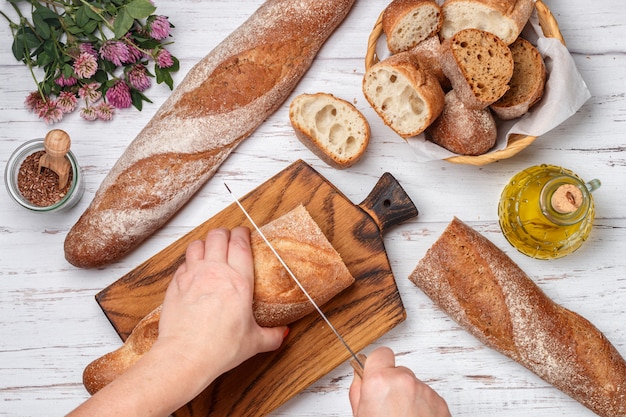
[153,227,286,386]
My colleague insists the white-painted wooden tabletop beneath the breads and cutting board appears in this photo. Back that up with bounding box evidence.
[0,0,626,417]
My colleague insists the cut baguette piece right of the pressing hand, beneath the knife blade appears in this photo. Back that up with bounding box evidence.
[251,205,354,327]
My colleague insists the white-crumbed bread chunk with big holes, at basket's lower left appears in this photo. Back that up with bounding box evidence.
[363,52,444,138]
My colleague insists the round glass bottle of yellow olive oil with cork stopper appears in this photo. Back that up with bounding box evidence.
[498,164,600,259]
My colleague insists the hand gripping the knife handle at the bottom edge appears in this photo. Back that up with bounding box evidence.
[350,348,450,417]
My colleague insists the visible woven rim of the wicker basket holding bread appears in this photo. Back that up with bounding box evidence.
[365,0,565,165]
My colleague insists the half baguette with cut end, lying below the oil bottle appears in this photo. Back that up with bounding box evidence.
[410,218,626,417]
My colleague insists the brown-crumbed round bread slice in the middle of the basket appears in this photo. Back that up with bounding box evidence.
[441,29,513,109]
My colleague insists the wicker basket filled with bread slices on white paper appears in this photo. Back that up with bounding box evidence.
[363,0,590,165]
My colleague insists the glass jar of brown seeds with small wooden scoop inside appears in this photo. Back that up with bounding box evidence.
[4,129,84,213]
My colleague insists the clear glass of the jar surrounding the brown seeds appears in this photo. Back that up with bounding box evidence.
[4,138,85,213]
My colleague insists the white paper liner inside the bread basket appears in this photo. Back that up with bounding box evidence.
[377,9,591,162]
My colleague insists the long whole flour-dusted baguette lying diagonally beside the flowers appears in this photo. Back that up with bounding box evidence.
[65,0,354,267]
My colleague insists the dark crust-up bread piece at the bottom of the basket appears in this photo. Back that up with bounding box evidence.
[426,90,498,155]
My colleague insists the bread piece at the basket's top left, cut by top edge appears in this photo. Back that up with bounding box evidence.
[382,0,443,54]
